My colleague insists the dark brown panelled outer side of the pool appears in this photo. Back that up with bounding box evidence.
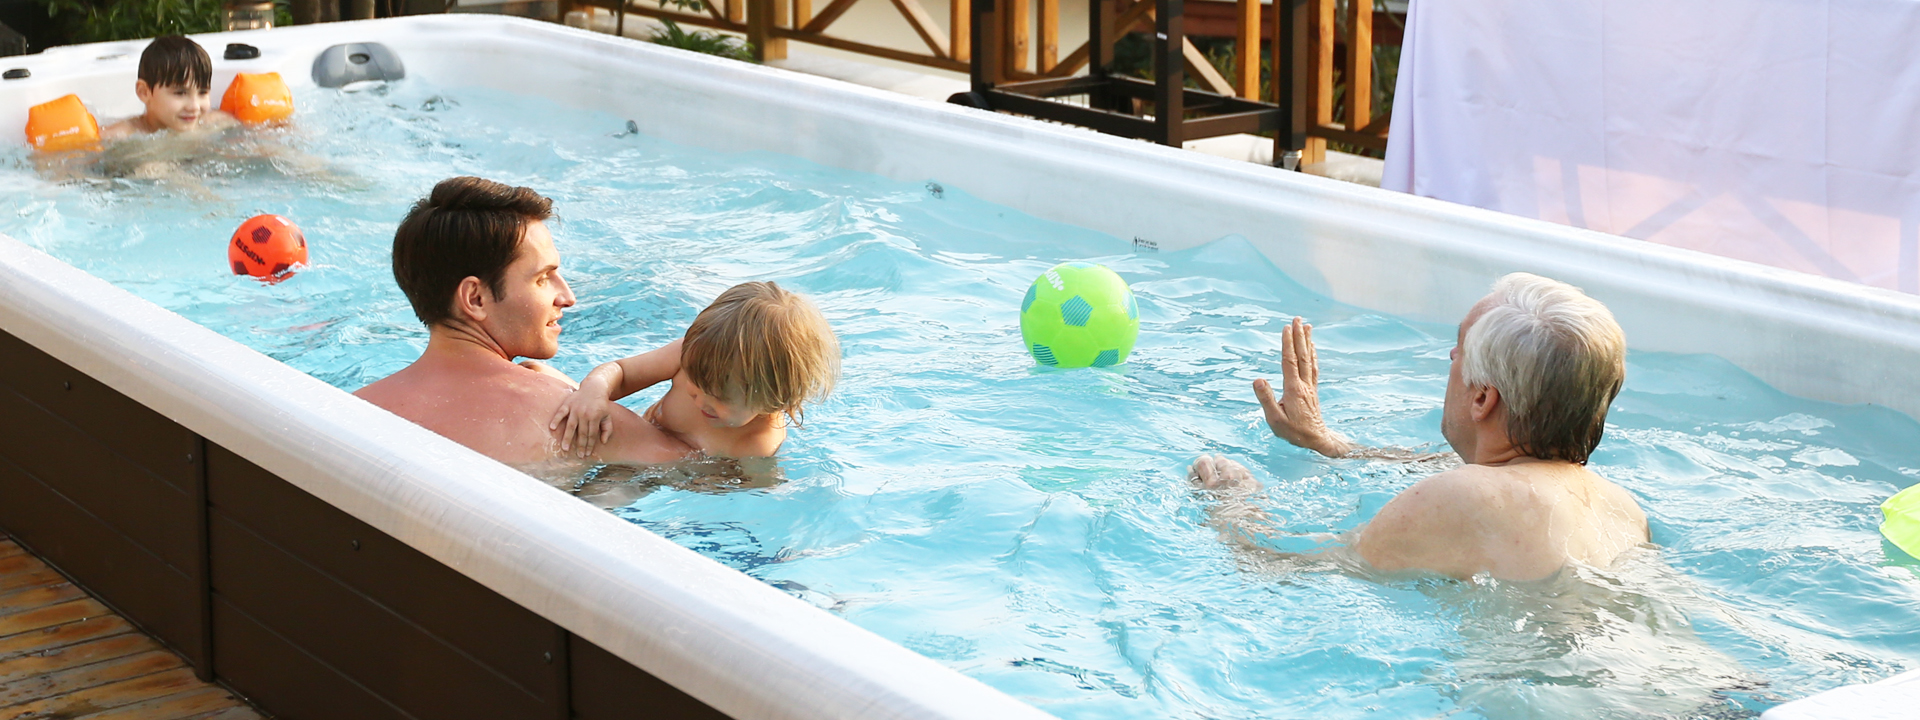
[0,332,724,720]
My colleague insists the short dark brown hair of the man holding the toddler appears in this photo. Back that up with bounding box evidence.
[394,177,553,326]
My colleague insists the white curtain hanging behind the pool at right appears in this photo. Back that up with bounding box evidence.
[1382,0,1920,292]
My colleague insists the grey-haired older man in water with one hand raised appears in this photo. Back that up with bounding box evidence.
[1190,273,1647,580]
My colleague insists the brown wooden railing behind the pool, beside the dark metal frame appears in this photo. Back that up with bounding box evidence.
[566,0,1398,163]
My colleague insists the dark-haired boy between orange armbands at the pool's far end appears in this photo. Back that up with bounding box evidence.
[102,35,234,140]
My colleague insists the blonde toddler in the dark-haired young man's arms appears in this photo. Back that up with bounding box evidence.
[547,282,839,459]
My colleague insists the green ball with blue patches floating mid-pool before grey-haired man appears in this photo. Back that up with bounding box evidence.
[1020,263,1140,367]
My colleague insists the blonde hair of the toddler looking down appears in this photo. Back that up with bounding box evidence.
[680,282,839,424]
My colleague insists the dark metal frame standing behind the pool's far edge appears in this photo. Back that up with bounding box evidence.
[948,0,1294,163]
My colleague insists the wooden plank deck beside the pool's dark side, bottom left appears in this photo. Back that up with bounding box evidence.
[0,536,261,720]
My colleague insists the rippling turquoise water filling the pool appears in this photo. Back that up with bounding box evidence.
[0,83,1920,720]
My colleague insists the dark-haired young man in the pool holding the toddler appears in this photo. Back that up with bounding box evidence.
[355,177,693,468]
